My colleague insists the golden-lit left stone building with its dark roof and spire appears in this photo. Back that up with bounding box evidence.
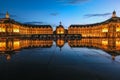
[0,12,53,36]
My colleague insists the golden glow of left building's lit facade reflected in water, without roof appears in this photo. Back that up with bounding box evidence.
[0,39,53,51]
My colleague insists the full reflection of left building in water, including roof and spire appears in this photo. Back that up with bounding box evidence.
[0,38,53,60]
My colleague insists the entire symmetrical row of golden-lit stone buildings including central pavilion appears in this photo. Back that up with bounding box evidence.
[0,11,120,38]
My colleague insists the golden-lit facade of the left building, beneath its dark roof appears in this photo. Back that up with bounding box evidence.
[0,19,53,35]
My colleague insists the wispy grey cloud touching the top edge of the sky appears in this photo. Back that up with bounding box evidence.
[57,0,89,5]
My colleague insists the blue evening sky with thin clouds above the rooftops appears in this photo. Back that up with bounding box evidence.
[0,0,120,28]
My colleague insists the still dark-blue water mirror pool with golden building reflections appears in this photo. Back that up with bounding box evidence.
[0,38,120,80]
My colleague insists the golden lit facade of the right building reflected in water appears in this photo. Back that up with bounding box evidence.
[68,38,120,51]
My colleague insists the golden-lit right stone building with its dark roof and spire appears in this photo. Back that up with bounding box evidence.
[68,11,120,38]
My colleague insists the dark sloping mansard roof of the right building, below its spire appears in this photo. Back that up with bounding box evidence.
[70,17,120,27]
